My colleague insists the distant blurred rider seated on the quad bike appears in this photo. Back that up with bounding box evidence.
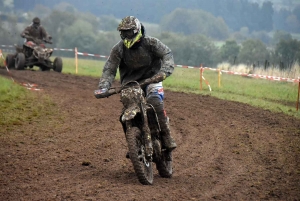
[21,17,52,42]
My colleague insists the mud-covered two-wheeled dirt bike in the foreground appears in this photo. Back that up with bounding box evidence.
[94,81,173,185]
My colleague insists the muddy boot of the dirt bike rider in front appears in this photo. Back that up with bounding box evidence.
[160,118,177,151]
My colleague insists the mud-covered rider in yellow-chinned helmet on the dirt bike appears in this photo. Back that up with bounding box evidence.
[98,16,177,151]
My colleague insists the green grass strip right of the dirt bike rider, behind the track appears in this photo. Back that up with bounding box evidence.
[164,69,300,118]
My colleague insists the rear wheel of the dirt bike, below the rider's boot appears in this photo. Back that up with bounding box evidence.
[156,151,173,178]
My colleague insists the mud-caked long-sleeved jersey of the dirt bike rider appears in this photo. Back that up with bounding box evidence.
[99,36,174,88]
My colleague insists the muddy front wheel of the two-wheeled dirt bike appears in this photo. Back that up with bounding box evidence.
[126,127,153,185]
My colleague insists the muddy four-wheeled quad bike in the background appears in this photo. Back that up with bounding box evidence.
[6,35,63,72]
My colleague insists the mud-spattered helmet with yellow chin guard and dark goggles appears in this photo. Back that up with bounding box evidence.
[117,16,143,48]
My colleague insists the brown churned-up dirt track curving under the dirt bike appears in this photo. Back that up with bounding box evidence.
[0,69,300,201]
